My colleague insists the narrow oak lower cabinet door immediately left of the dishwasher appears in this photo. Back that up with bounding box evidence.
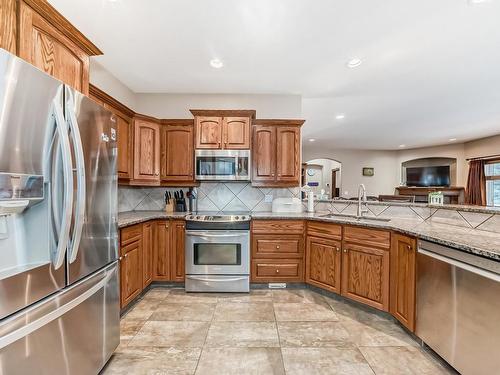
[390,234,416,332]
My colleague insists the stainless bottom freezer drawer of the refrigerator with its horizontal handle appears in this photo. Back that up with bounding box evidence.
[0,263,120,375]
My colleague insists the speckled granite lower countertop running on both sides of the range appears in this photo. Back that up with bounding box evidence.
[118,211,500,261]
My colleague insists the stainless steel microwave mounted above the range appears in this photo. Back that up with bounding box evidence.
[195,150,250,181]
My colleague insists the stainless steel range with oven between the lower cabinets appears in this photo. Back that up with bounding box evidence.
[186,214,250,292]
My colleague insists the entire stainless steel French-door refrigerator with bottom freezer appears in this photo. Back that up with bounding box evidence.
[0,49,120,375]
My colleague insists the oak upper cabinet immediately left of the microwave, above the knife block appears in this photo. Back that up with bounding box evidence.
[160,121,194,182]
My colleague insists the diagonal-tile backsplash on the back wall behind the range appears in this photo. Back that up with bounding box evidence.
[118,182,300,212]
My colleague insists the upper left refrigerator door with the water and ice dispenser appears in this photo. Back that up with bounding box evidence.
[0,49,67,319]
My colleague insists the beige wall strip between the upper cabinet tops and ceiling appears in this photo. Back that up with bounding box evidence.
[136,94,302,119]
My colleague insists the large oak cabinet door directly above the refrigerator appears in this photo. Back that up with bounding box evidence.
[18,1,89,94]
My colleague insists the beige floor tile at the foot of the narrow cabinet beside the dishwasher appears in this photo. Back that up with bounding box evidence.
[342,321,418,346]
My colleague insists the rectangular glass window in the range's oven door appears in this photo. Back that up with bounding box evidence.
[194,243,241,266]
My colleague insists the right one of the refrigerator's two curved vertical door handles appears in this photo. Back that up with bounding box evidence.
[66,89,86,263]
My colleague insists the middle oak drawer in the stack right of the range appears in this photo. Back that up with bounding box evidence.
[252,234,304,258]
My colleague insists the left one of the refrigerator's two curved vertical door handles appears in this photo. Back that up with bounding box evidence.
[52,91,73,269]
